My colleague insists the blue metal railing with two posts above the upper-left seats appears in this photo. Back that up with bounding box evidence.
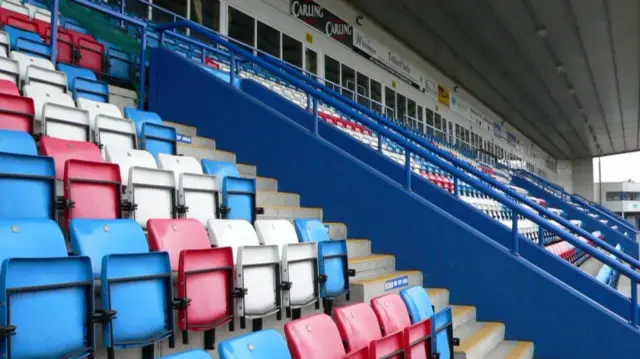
[50,0,147,110]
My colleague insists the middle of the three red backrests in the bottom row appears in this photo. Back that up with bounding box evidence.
[333,303,382,352]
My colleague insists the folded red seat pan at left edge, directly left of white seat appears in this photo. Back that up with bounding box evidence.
[0,93,34,133]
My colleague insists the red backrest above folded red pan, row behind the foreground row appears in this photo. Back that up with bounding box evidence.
[40,136,104,180]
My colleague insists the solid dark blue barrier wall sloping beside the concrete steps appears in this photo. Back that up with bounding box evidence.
[149,49,640,358]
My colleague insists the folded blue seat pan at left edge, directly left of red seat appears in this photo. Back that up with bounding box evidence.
[0,150,56,219]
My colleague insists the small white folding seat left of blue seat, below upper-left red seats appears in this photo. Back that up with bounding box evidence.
[11,51,67,92]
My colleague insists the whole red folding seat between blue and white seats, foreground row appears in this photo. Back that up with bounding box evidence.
[147,219,234,350]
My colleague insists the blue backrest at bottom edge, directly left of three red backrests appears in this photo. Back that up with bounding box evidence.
[218,329,291,359]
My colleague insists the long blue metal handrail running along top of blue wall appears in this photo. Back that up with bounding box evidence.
[156,21,640,325]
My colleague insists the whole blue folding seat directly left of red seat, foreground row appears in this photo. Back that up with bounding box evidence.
[70,219,175,358]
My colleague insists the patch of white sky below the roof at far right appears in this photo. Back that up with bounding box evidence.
[593,152,640,182]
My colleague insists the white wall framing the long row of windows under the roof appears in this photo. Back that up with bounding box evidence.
[223,0,551,173]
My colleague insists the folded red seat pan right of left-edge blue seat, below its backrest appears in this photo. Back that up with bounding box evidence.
[64,159,122,228]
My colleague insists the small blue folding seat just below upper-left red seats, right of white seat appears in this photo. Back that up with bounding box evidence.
[58,63,109,103]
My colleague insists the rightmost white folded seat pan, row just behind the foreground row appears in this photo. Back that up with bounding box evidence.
[178,173,220,226]
